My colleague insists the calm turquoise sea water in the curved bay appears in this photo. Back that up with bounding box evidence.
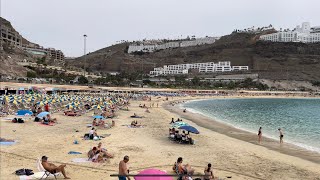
[182,98,320,152]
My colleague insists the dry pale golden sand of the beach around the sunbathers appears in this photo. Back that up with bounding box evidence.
[0,97,320,179]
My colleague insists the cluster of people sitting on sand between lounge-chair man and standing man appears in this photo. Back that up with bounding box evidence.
[88,142,113,163]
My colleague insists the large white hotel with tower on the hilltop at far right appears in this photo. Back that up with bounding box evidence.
[260,22,320,43]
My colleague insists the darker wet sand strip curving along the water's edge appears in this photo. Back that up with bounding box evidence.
[163,96,320,164]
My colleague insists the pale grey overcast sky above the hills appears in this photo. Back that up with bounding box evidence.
[0,0,320,56]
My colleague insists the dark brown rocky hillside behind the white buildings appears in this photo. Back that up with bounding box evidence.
[68,33,320,81]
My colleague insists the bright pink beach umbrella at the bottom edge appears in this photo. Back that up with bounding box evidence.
[134,169,173,180]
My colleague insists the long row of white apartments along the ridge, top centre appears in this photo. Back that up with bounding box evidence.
[128,37,218,53]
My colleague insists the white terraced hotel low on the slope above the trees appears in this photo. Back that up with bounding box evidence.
[150,61,249,76]
